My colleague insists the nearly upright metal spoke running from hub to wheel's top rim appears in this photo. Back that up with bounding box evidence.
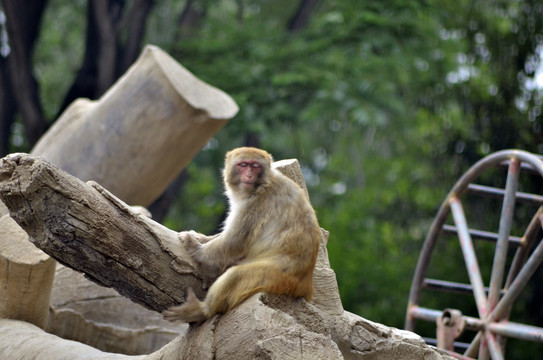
[488,158,520,311]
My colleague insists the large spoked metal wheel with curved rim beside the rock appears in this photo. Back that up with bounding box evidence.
[405,150,543,360]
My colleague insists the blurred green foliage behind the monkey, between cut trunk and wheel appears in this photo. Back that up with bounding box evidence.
[149,1,537,336]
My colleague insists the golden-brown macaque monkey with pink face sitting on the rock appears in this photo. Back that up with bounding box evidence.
[163,147,321,322]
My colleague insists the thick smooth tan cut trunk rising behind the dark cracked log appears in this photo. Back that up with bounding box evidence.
[32,45,239,206]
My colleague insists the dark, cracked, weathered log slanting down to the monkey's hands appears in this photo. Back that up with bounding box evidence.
[0,154,200,311]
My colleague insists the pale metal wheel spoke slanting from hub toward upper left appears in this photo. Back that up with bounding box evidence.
[450,196,487,319]
